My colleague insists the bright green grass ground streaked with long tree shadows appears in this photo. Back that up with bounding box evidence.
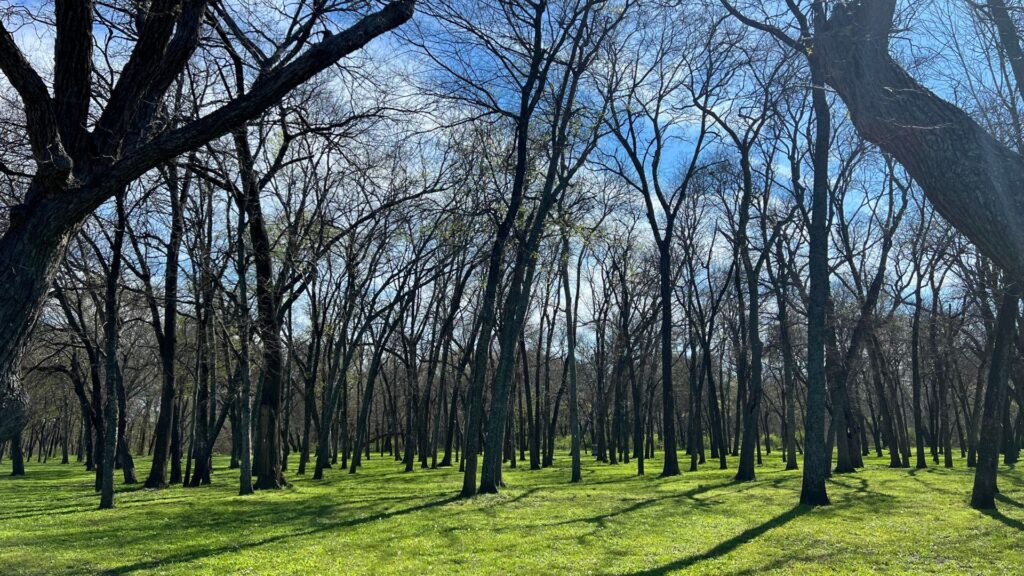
[0,455,1024,576]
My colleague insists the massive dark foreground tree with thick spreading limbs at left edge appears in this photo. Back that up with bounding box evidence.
[0,0,416,440]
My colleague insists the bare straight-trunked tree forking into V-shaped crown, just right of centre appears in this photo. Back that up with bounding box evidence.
[603,2,711,477]
